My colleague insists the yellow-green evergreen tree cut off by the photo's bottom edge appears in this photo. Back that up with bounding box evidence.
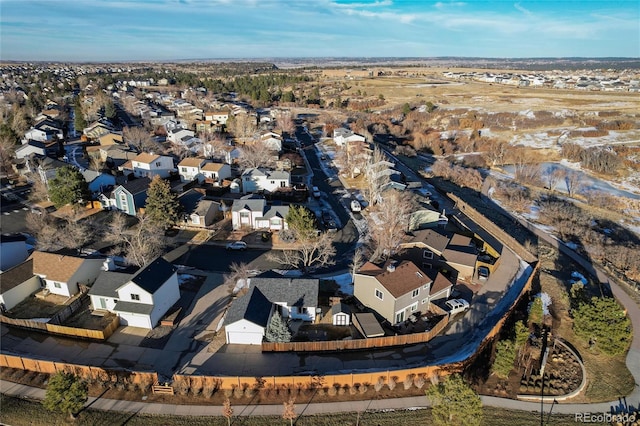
[427,374,482,426]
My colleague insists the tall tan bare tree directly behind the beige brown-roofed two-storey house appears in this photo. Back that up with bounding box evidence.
[369,191,413,259]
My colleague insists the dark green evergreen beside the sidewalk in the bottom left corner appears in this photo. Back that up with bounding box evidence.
[42,372,88,419]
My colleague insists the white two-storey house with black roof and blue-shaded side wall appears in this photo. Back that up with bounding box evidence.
[89,257,180,329]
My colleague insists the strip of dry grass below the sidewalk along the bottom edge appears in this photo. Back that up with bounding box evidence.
[0,395,606,426]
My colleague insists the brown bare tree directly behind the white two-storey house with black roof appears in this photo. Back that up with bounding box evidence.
[106,213,165,266]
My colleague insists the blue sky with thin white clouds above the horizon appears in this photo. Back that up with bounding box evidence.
[0,0,640,61]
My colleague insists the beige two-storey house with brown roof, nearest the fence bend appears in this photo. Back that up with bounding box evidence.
[353,260,452,324]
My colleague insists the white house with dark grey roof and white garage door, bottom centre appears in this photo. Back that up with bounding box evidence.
[224,277,320,345]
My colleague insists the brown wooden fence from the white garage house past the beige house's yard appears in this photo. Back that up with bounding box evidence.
[262,315,449,352]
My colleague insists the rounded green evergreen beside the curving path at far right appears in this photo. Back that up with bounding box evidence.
[573,297,631,356]
